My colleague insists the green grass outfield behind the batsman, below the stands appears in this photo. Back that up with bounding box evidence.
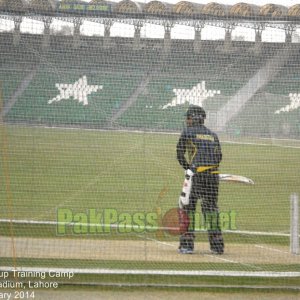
[0,126,300,240]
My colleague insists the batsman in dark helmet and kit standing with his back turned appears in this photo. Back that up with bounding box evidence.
[177,105,224,254]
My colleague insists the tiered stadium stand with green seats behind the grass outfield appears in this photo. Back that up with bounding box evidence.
[0,13,299,136]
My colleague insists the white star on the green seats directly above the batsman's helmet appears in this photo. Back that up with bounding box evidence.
[162,81,221,109]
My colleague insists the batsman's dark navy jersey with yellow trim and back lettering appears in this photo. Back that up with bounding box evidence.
[177,125,222,172]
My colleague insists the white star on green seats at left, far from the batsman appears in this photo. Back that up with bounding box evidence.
[48,76,103,105]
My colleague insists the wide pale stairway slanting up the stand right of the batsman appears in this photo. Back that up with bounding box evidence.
[216,45,299,131]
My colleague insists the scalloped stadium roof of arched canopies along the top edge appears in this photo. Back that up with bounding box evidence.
[0,0,300,19]
